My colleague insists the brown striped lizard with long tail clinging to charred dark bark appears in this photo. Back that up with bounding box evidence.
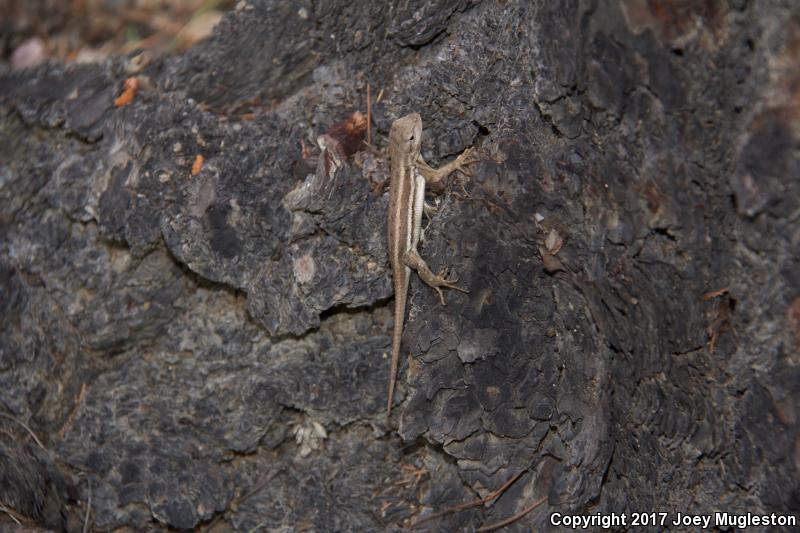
[386,113,476,420]
